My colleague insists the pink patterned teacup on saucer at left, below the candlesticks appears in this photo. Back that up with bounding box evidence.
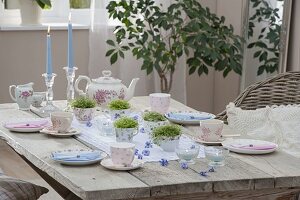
[51,111,73,133]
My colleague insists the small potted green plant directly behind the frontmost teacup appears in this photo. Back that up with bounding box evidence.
[114,117,139,142]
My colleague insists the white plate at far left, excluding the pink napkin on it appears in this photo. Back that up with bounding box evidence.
[3,119,48,133]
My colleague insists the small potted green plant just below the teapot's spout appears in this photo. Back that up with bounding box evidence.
[108,99,131,120]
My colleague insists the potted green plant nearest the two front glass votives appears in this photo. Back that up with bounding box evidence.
[151,124,182,152]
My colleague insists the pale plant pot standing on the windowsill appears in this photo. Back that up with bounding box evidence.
[19,0,42,24]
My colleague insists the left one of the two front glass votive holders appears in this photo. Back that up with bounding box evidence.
[175,141,200,164]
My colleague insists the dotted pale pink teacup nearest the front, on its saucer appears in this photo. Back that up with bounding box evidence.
[110,142,135,166]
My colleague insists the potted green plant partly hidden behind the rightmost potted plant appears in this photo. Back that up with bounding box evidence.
[143,112,168,133]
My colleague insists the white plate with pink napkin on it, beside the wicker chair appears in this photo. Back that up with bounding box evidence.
[222,139,278,154]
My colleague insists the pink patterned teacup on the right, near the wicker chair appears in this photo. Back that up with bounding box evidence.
[198,119,224,142]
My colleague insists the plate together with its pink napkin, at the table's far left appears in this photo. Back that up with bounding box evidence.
[3,119,49,133]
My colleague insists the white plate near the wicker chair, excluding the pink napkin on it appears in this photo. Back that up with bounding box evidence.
[222,139,278,154]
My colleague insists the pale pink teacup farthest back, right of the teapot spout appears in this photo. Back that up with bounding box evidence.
[149,93,171,114]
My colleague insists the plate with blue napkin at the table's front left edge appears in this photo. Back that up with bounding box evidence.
[50,150,107,166]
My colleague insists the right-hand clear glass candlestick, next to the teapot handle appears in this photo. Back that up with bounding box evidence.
[63,67,78,112]
